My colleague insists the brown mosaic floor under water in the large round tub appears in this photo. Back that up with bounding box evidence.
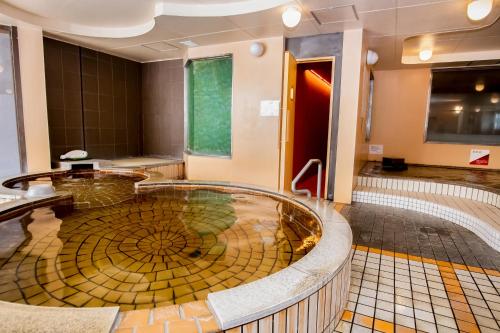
[0,189,320,310]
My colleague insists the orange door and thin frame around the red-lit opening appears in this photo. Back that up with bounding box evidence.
[278,51,336,199]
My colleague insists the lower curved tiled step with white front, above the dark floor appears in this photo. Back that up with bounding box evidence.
[352,186,500,251]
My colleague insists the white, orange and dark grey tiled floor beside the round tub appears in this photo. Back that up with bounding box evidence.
[336,204,500,332]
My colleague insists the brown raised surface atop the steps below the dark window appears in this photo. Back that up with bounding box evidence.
[360,162,500,192]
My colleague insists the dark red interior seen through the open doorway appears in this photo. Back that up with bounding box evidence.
[293,62,332,194]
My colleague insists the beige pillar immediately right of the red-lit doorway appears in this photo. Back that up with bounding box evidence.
[334,29,366,203]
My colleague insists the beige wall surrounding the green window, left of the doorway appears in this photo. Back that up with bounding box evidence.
[185,37,283,189]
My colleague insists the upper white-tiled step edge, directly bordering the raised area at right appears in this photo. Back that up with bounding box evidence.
[357,176,500,208]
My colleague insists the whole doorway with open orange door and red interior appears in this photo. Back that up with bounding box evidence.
[280,52,335,198]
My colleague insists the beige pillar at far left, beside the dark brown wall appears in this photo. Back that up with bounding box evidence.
[17,24,50,172]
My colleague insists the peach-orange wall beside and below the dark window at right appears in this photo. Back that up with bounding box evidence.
[369,69,500,169]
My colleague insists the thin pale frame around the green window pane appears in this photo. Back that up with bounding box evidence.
[184,53,234,159]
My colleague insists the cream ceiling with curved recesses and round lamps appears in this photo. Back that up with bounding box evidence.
[0,0,500,69]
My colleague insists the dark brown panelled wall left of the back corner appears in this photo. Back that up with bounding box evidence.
[44,38,142,160]
